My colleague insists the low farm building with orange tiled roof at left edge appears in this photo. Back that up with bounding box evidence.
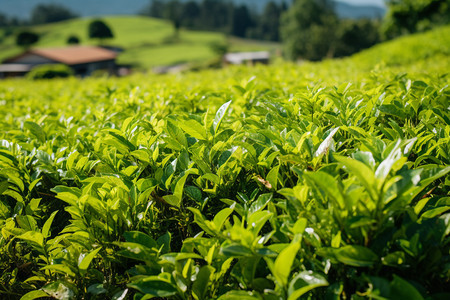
[0,46,118,78]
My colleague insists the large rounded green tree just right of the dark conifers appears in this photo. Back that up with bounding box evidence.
[280,0,337,60]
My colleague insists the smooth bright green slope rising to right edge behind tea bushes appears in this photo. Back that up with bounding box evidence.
[305,26,450,82]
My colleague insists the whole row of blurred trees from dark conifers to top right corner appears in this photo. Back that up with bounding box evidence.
[141,0,450,60]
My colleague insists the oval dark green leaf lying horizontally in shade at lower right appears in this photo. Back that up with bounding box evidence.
[335,245,378,267]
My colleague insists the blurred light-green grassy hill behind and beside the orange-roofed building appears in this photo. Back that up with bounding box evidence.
[0,16,277,68]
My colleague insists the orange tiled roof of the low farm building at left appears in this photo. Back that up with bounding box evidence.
[29,46,117,65]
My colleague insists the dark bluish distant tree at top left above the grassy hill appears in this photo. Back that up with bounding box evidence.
[31,4,78,24]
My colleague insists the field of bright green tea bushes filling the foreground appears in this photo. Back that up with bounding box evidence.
[0,27,450,300]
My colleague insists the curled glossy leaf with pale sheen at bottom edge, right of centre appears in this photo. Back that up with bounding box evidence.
[288,271,328,300]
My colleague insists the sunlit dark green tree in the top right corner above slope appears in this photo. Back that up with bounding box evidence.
[381,0,450,39]
